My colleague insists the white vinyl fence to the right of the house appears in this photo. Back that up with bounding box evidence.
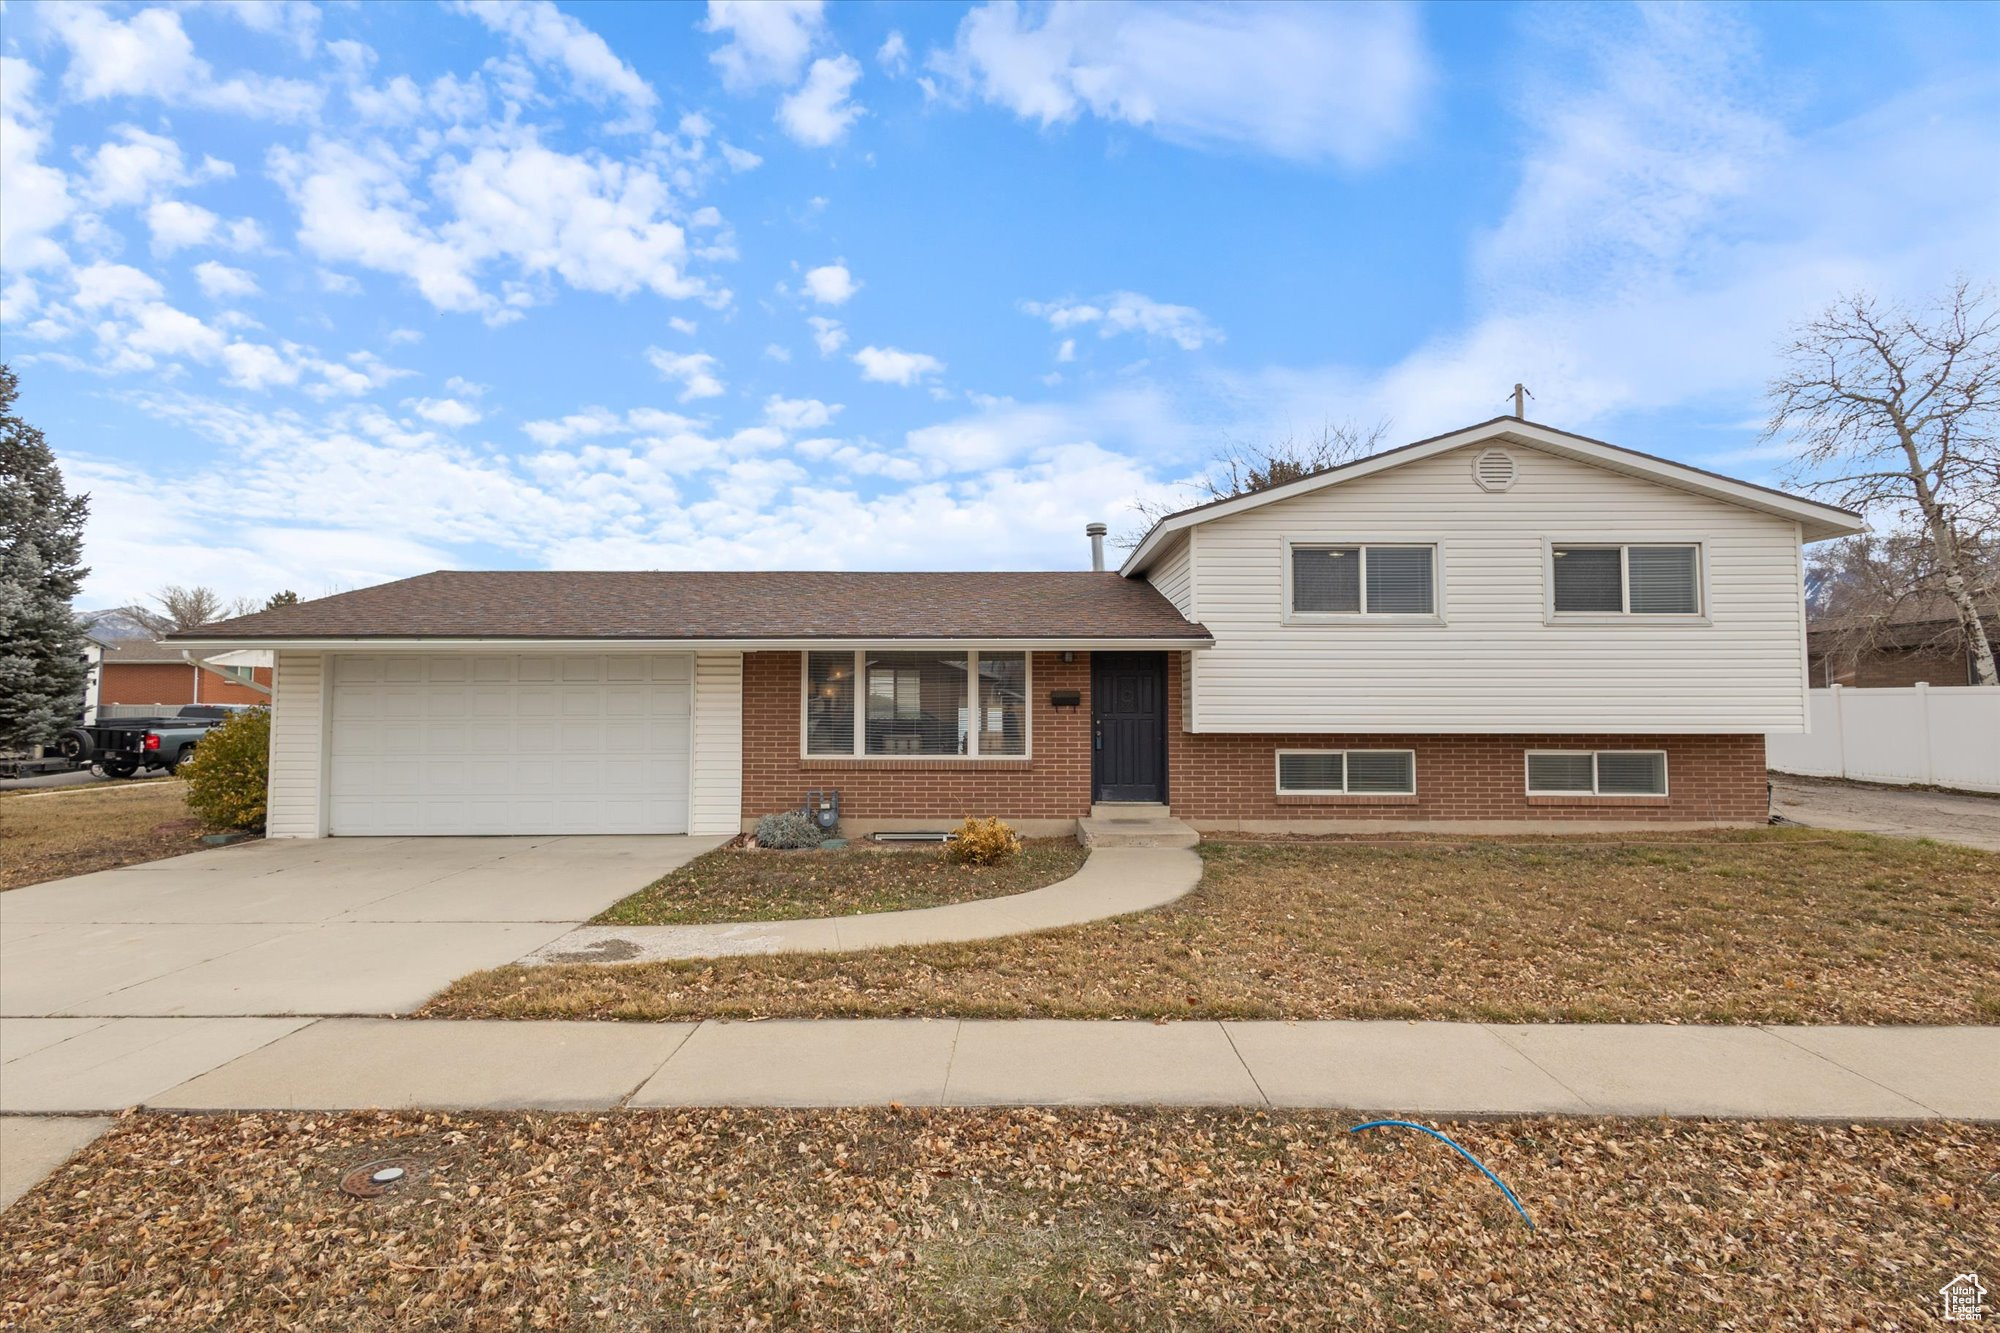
[1764,685,2000,793]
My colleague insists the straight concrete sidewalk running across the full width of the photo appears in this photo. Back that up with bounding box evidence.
[0,1019,2000,1121]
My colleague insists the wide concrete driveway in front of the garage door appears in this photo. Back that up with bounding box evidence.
[0,837,722,1019]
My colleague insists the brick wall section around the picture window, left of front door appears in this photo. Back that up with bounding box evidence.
[742,652,1090,823]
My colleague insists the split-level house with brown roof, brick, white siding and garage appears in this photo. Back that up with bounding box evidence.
[172,418,1862,837]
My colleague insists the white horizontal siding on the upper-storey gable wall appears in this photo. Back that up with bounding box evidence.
[1190,444,1806,735]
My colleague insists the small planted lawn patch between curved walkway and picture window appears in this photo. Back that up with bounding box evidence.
[598,839,1084,925]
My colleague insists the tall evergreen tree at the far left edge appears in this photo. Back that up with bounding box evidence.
[0,364,90,749]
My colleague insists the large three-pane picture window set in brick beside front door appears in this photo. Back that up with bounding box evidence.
[804,648,1028,759]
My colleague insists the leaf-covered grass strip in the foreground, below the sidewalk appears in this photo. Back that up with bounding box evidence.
[0,1109,2000,1333]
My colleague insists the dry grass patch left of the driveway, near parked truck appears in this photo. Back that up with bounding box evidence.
[0,777,223,889]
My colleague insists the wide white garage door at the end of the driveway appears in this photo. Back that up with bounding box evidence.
[328,654,692,835]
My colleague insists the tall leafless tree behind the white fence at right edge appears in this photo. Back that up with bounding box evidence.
[1764,280,2000,685]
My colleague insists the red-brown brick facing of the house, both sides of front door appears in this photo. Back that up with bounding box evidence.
[744,652,1768,829]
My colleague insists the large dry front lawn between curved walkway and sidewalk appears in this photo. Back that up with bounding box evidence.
[426,829,2000,1023]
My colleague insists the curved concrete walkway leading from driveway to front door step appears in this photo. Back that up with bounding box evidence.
[522,847,1202,965]
